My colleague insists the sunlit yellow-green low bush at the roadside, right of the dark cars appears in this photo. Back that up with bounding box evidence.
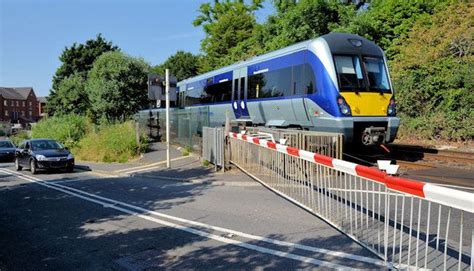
[73,121,147,163]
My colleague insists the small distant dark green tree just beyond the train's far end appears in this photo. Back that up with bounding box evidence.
[151,51,200,81]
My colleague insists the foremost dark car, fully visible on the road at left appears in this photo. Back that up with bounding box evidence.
[15,139,74,174]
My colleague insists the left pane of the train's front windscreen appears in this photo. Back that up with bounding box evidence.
[334,56,366,91]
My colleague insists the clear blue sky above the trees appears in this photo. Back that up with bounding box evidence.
[0,0,274,96]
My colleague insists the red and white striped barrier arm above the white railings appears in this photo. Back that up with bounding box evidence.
[229,132,474,213]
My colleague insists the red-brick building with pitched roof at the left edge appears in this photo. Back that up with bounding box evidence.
[0,87,39,125]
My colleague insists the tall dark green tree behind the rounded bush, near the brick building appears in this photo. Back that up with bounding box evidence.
[47,34,119,115]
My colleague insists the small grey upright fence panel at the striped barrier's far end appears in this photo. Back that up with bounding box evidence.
[202,127,225,167]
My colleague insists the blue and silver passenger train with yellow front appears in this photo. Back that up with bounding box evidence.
[144,33,400,145]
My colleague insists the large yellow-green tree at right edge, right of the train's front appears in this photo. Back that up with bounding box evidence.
[390,3,474,139]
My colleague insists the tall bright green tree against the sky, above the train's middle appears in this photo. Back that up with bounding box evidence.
[193,0,263,72]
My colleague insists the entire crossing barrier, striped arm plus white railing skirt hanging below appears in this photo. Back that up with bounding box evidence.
[228,133,474,270]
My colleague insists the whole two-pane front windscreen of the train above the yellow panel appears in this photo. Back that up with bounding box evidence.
[334,55,390,92]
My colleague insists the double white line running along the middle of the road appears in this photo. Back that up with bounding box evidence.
[0,169,387,269]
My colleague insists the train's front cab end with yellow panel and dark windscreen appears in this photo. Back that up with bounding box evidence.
[314,33,400,145]
